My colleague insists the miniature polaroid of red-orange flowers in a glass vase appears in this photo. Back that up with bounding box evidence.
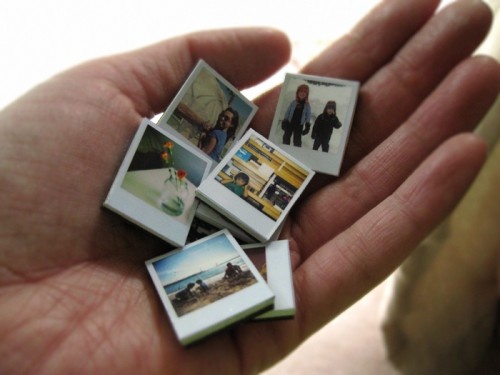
[103,119,212,246]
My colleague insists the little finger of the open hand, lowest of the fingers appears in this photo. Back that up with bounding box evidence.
[295,134,486,332]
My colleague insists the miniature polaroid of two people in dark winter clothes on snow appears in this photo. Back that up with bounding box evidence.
[269,73,359,176]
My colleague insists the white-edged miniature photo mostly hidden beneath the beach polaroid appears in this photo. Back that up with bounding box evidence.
[242,240,295,320]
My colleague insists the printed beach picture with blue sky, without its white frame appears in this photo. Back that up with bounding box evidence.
[153,233,257,317]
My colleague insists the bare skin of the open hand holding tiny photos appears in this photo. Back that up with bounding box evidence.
[0,0,500,374]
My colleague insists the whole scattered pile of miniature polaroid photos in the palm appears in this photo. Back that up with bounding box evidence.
[103,61,359,345]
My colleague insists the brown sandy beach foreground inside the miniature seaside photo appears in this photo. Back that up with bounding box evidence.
[169,271,257,316]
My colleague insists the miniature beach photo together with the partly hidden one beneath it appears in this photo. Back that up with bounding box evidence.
[146,230,295,345]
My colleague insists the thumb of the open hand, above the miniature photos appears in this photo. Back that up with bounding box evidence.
[58,28,290,117]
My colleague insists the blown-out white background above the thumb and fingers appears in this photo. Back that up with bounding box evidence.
[0,0,458,109]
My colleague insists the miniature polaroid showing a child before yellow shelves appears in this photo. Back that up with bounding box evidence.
[196,129,314,242]
